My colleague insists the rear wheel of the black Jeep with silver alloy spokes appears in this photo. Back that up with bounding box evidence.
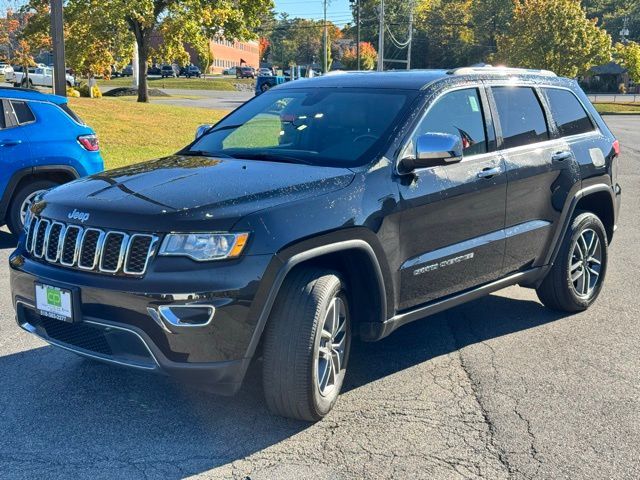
[536,212,608,313]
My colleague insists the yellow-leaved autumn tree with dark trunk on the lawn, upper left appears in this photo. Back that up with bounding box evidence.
[25,0,273,102]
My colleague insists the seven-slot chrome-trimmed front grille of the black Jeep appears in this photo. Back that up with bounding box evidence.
[26,217,158,276]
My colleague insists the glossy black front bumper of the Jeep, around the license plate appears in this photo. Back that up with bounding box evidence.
[10,252,271,394]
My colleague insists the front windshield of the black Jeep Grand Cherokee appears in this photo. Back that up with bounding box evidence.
[182,88,417,167]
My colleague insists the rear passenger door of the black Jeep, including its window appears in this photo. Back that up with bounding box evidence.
[489,84,579,273]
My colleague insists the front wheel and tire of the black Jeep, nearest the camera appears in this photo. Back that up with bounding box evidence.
[262,268,351,422]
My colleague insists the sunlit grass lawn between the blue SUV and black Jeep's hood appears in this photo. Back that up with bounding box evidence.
[69,98,227,169]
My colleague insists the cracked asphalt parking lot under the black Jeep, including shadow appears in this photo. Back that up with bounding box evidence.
[0,116,640,480]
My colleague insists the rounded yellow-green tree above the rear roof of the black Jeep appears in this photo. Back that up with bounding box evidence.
[496,0,611,77]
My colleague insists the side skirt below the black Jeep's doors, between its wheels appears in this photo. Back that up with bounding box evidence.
[360,267,545,341]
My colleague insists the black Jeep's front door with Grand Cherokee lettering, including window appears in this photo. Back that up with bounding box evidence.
[398,87,507,310]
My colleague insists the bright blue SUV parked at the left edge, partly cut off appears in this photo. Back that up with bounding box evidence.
[0,87,104,234]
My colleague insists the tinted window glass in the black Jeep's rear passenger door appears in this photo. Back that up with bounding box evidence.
[492,87,549,148]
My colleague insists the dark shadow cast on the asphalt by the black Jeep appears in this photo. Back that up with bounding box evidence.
[0,296,560,478]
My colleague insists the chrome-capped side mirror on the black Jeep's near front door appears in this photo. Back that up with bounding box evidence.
[400,133,462,172]
